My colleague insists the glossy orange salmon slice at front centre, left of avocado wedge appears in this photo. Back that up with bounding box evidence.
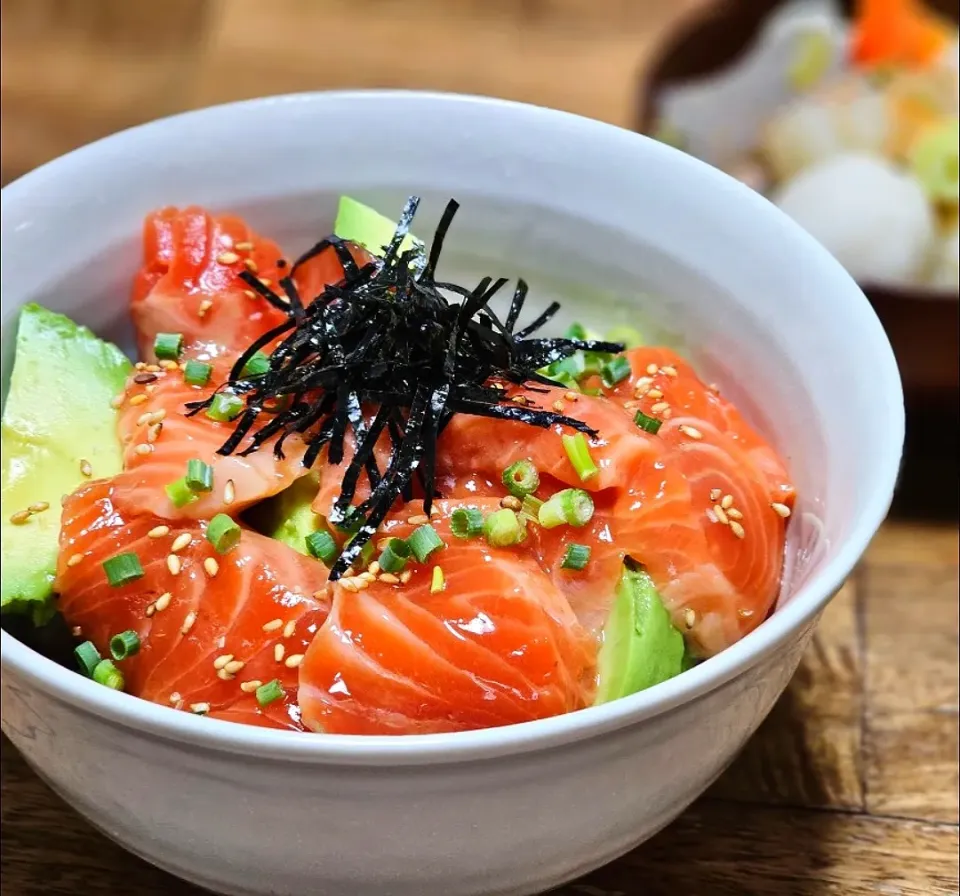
[299,502,596,734]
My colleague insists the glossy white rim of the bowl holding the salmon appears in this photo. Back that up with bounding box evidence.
[0,90,904,766]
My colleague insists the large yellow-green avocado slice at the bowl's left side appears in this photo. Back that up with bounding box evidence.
[0,304,131,623]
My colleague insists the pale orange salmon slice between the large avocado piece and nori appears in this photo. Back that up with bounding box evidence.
[114,354,309,520]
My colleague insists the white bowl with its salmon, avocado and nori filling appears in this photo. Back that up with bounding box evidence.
[0,93,903,896]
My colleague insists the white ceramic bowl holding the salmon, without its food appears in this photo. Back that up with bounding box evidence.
[2,92,903,896]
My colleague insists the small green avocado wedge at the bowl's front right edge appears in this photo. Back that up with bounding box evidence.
[596,564,684,703]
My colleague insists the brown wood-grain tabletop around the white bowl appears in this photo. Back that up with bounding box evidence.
[0,0,960,896]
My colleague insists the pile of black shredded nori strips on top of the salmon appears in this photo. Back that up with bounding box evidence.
[188,196,623,579]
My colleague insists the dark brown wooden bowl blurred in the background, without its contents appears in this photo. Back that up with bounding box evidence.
[637,0,960,400]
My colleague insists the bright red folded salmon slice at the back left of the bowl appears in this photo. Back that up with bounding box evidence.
[130,206,287,360]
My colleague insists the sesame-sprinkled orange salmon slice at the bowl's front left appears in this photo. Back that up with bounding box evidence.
[56,480,330,729]
